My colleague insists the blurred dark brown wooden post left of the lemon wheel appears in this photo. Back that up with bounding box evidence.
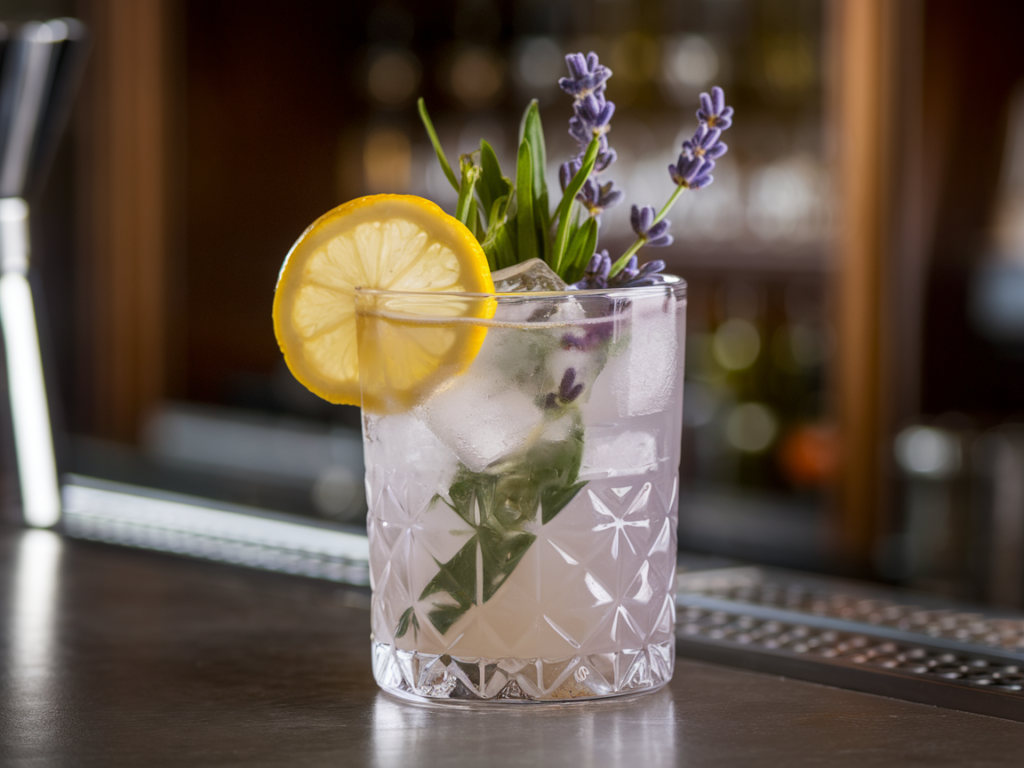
[77,0,169,441]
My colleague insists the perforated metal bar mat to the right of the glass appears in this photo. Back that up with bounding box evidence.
[676,567,1024,722]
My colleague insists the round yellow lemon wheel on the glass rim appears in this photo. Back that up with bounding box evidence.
[273,195,496,413]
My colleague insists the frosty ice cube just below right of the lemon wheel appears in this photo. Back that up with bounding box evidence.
[418,365,544,472]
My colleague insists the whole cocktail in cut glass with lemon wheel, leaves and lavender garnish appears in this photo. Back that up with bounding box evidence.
[274,53,732,700]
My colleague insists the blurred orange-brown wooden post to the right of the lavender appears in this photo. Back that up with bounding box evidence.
[831,0,899,570]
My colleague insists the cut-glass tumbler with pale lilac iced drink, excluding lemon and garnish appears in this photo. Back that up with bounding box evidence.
[360,283,685,702]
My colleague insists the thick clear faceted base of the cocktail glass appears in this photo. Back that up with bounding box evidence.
[373,639,676,703]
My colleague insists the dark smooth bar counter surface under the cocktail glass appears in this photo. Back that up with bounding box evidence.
[0,528,1024,768]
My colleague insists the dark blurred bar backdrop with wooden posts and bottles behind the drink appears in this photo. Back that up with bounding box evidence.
[6,0,1024,607]
